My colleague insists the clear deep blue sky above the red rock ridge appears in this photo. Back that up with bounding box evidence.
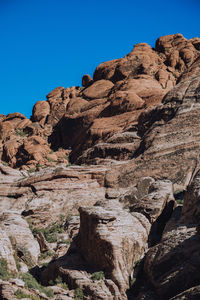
[0,0,200,117]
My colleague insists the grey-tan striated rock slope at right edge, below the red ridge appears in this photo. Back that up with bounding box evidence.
[107,63,200,189]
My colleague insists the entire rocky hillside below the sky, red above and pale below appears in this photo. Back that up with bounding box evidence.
[0,34,200,300]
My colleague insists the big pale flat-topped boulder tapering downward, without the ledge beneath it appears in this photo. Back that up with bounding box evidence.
[78,202,150,297]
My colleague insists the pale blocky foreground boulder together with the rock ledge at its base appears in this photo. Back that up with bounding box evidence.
[42,200,150,300]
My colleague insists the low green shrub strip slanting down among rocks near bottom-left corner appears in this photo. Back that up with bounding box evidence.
[21,273,54,298]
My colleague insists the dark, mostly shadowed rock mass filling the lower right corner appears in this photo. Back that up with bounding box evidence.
[141,172,200,299]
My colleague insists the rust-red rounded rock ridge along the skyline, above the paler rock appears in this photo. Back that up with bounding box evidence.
[0,34,200,169]
